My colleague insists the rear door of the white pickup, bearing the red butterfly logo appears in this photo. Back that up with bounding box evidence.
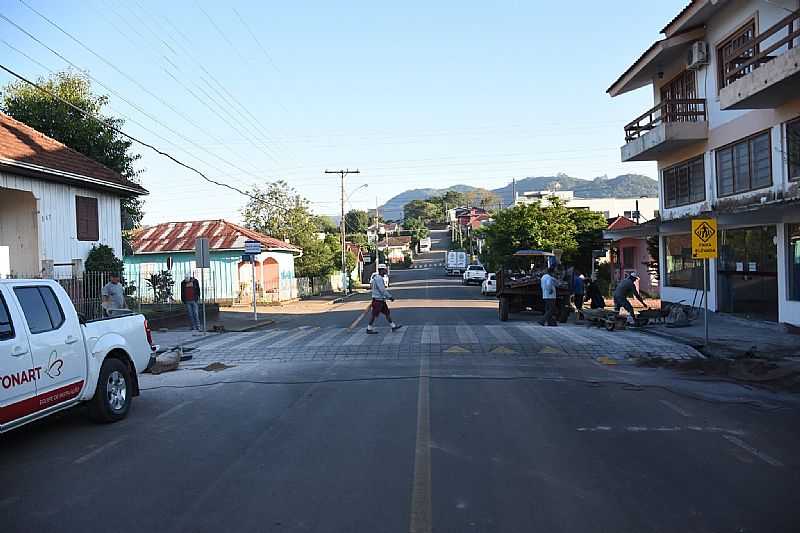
[14,283,86,409]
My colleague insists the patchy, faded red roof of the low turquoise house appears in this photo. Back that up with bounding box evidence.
[132,220,302,254]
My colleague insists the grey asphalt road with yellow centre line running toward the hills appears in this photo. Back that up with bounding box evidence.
[0,230,800,533]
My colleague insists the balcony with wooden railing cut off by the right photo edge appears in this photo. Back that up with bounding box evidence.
[719,10,800,109]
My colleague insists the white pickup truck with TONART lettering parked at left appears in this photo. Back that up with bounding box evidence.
[0,279,156,433]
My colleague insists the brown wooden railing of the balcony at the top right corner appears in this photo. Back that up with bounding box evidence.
[721,10,800,87]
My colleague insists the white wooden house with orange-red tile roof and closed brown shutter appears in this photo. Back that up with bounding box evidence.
[0,113,147,277]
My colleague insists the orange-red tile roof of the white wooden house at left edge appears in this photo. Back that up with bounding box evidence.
[0,113,147,194]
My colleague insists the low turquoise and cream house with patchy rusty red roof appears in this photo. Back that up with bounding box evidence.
[125,220,303,304]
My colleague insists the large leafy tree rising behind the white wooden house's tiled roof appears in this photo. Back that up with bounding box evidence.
[0,70,143,245]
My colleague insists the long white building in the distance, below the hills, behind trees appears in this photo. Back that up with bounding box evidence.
[514,190,658,222]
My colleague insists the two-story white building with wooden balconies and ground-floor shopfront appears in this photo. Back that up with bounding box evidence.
[607,0,800,325]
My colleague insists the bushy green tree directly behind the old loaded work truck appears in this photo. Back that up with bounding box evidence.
[477,198,578,268]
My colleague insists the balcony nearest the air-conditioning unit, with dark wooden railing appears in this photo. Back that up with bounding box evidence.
[621,98,708,161]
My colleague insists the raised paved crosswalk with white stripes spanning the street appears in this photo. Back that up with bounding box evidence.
[180,323,698,366]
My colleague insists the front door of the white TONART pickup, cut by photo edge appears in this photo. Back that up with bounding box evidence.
[0,287,39,429]
